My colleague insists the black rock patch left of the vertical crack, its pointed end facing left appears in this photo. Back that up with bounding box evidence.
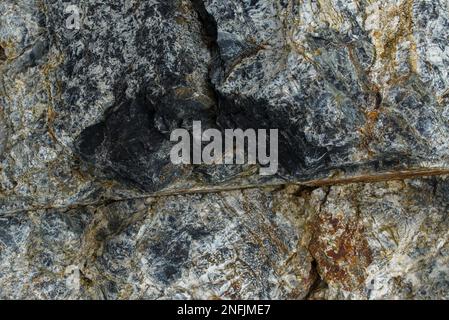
[77,94,175,191]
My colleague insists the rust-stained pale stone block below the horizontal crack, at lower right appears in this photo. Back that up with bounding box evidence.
[309,179,449,299]
